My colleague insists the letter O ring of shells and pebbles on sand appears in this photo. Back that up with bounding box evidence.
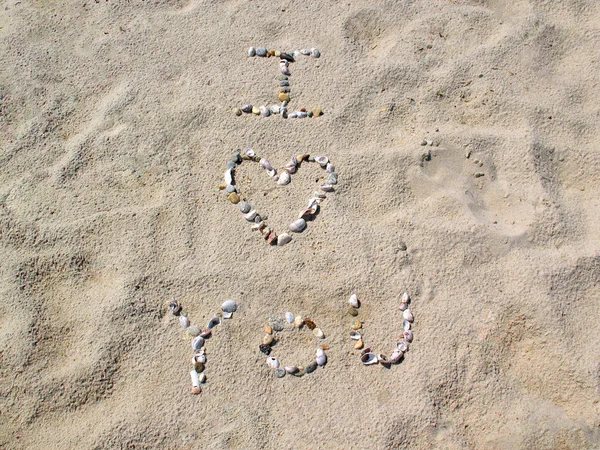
[259,311,329,378]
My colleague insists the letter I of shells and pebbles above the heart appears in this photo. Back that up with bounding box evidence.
[235,47,323,119]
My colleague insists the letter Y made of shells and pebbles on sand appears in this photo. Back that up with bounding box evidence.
[169,299,237,395]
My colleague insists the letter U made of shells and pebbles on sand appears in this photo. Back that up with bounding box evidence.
[348,292,415,367]
